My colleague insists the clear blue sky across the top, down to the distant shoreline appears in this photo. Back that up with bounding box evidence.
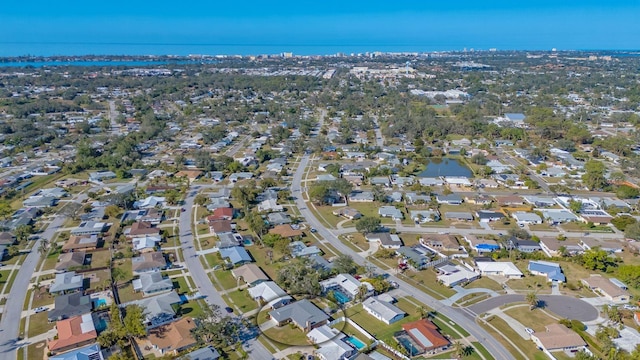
[0,0,640,55]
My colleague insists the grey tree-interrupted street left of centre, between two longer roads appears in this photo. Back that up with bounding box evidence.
[179,186,273,360]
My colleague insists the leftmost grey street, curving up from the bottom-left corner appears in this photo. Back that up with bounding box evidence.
[0,215,67,360]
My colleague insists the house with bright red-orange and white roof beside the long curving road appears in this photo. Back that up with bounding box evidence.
[394,319,450,356]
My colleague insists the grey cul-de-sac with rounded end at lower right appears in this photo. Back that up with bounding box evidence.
[468,295,598,322]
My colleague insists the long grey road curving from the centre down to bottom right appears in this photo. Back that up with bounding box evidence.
[292,155,512,359]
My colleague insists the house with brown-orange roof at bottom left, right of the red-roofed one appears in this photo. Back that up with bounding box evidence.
[147,317,197,355]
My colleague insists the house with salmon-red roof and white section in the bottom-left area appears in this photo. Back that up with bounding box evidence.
[47,314,98,354]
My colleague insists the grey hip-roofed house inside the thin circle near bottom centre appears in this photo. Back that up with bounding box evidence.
[269,299,329,332]
